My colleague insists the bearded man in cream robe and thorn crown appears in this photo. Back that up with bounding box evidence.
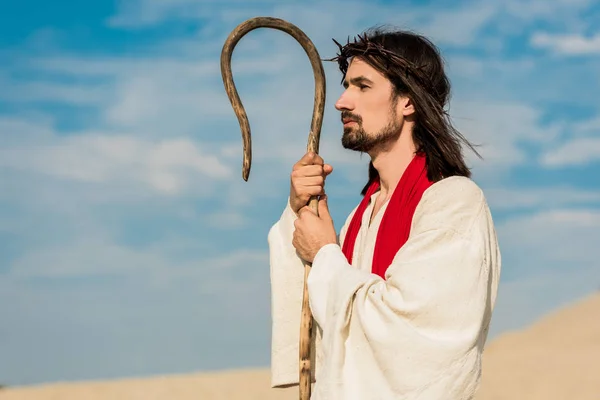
[269,26,500,400]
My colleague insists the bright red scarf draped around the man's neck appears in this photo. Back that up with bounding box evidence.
[342,153,433,279]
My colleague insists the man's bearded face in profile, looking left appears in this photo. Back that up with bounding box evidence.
[335,58,403,152]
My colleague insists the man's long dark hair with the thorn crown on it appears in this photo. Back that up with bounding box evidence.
[329,28,481,195]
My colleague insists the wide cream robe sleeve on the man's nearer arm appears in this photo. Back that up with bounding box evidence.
[308,179,499,393]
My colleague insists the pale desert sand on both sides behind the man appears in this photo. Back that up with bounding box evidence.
[0,294,600,400]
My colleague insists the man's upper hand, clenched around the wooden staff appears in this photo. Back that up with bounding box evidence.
[290,152,333,214]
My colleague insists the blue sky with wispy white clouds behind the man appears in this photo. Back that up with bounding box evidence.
[0,0,600,385]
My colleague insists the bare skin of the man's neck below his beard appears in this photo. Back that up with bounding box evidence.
[371,124,416,198]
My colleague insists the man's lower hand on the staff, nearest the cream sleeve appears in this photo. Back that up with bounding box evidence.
[292,196,337,263]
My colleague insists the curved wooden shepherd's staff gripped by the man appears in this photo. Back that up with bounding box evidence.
[221,17,325,400]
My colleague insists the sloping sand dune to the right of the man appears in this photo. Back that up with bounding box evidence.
[477,293,600,400]
